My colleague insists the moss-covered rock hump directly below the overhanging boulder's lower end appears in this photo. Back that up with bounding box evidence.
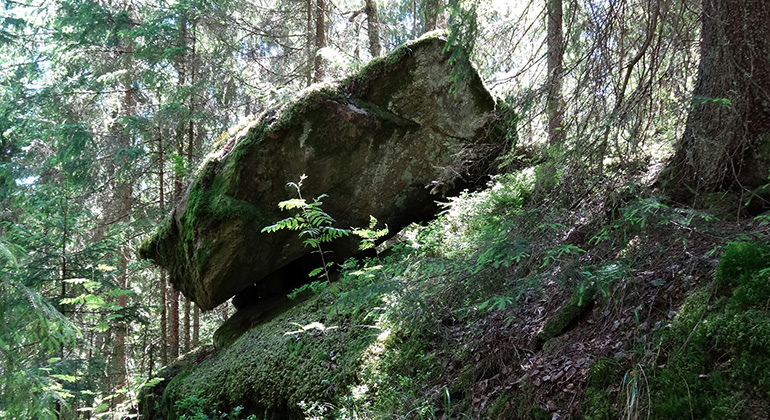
[152,288,378,419]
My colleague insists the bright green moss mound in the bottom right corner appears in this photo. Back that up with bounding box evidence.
[651,243,770,419]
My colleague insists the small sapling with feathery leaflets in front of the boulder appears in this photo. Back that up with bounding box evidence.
[262,174,350,282]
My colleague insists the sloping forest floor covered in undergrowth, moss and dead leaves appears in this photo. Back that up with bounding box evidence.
[142,162,770,420]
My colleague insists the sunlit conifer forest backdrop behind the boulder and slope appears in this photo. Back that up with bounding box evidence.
[0,0,767,418]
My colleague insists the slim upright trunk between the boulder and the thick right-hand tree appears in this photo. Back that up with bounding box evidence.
[546,0,564,146]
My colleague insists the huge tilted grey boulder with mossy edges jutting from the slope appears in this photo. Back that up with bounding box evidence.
[141,38,510,309]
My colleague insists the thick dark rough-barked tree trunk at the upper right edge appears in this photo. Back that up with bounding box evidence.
[666,0,770,196]
